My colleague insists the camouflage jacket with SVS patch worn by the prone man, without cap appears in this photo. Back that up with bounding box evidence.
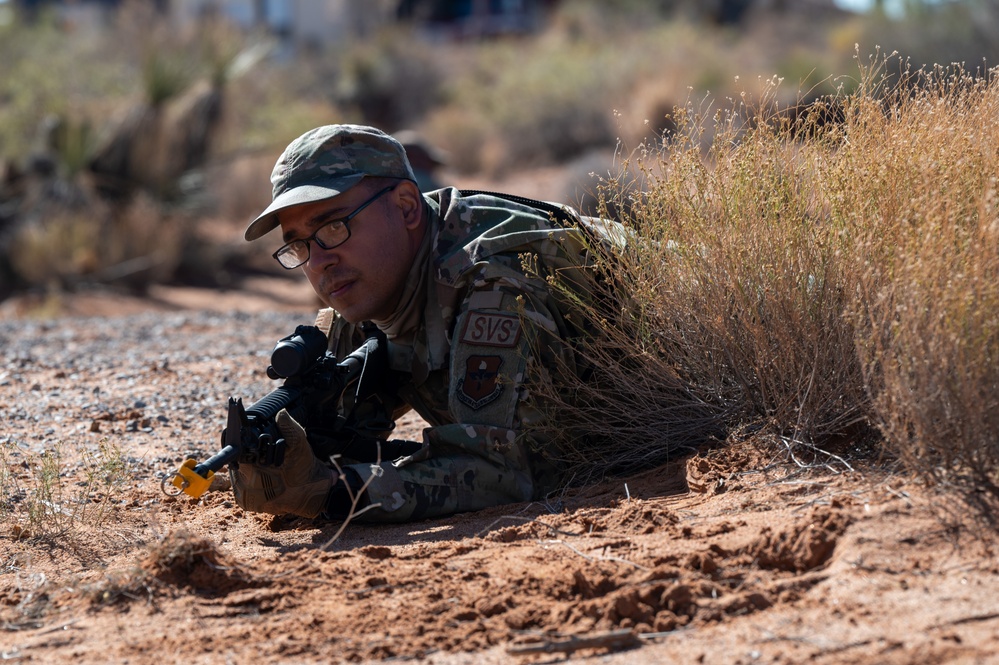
[328,188,623,521]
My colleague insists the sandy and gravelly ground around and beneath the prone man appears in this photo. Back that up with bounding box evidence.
[0,163,999,665]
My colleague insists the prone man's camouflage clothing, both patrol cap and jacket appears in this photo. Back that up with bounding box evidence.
[234,125,623,521]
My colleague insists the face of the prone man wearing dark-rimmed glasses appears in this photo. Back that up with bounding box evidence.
[278,181,419,323]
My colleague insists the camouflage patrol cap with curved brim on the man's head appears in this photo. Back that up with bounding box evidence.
[243,125,416,240]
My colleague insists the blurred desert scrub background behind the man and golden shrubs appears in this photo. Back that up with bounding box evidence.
[0,0,999,307]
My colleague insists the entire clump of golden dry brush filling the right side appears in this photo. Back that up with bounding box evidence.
[539,56,999,508]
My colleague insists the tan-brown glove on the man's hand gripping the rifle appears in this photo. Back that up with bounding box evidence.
[229,409,337,517]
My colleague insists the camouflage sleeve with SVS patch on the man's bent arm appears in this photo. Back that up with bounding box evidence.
[332,276,571,522]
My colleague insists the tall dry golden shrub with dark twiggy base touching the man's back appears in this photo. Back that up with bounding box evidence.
[532,81,870,480]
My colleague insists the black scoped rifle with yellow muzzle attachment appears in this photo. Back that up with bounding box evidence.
[170,323,391,498]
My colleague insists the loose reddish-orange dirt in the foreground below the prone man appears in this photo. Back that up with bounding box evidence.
[0,296,999,665]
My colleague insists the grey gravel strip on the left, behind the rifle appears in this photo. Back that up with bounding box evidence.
[0,311,313,474]
